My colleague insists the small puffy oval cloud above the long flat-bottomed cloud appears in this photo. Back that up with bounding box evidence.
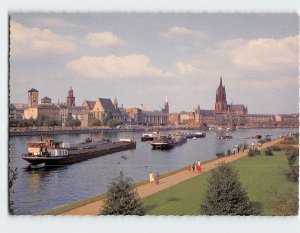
[86,32,125,48]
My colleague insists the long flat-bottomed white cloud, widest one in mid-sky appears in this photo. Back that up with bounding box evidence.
[67,54,172,78]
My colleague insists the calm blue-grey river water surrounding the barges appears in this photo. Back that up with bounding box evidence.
[9,129,297,215]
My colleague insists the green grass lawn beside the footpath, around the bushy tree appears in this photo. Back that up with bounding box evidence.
[143,151,298,215]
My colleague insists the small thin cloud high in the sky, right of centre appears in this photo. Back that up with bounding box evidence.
[161,26,208,38]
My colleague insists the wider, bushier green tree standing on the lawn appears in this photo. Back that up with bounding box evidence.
[200,164,254,215]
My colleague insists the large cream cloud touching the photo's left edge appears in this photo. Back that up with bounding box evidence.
[10,20,76,56]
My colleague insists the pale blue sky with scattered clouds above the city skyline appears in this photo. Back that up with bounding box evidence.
[9,13,299,114]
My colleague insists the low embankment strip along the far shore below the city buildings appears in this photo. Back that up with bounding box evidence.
[8,126,299,137]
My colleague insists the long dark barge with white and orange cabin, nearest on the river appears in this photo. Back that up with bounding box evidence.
[22,139,136,168]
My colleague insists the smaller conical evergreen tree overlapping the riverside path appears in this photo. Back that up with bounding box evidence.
[100,172,145,215]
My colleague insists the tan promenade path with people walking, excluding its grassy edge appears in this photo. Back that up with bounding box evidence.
[61,139,282,215]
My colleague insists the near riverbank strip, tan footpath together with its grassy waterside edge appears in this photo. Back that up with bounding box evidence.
[39,139,282,215]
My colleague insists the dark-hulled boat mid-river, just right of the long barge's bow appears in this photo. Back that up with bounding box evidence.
[151,135,187,150]
